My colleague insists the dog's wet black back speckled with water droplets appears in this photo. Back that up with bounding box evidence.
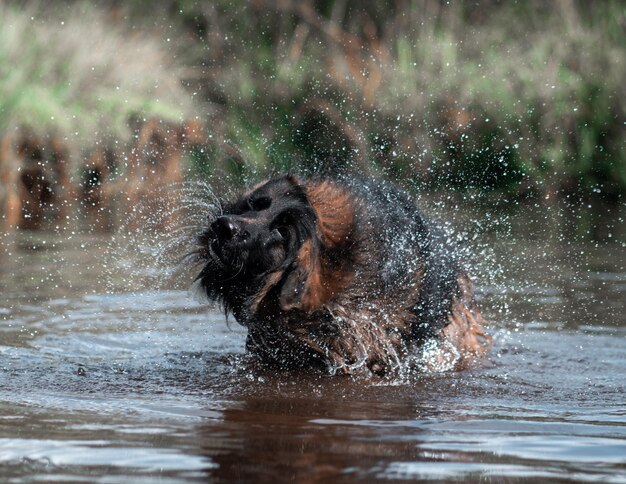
[336,179,465,342]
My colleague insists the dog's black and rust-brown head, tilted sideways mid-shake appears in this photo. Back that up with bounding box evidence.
[198,175,354,323]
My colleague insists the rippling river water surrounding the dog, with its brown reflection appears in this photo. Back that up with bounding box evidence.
[0,202,626,482]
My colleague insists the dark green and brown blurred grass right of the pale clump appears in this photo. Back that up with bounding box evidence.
[172,1,626,196]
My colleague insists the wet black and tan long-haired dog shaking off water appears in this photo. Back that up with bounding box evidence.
[195,175,491,376]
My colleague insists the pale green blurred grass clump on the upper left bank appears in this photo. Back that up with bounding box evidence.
[0,2,192,149]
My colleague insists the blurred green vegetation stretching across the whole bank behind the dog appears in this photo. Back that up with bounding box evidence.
[0,0,626,199]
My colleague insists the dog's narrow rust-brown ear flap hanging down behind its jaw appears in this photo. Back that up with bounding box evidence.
[280,240,325,312]
